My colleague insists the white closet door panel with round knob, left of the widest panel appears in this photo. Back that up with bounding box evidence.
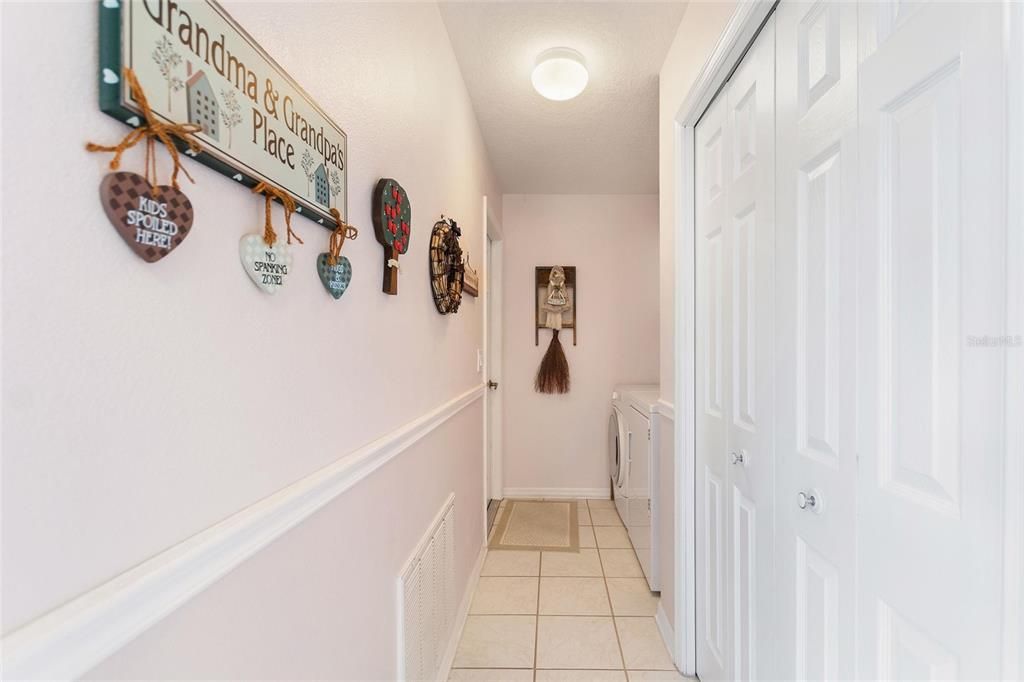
[775,2,857,680]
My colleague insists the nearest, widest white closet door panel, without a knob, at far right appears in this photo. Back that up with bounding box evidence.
[857,3,1007,680]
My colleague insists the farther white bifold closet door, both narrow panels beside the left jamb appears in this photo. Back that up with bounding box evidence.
[695,20,775,680]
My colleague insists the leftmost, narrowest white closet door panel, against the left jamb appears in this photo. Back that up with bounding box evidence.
[694,86,731,680]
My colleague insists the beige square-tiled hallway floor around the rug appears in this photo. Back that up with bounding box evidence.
[449,493,686,682]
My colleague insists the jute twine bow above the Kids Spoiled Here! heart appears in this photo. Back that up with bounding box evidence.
[85,68,203,194]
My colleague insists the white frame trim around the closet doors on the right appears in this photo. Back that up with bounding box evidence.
[671,0,1024,679]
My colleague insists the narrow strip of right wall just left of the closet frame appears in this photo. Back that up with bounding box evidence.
[658,0,736,627]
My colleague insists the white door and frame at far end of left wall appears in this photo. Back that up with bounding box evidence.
[479,196,504,512]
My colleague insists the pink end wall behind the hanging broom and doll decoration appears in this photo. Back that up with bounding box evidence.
[502,195,658,494]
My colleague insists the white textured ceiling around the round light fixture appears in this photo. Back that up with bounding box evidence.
[440,1,685,194]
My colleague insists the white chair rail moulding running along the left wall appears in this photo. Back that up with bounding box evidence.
[2,384,483,679]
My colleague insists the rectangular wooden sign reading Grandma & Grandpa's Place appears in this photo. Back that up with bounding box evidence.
[99,0,348,228]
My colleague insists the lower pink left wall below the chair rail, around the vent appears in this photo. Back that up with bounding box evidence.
[87,400,483,680]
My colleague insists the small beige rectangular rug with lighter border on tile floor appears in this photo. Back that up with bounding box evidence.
[488,500,580,552]
